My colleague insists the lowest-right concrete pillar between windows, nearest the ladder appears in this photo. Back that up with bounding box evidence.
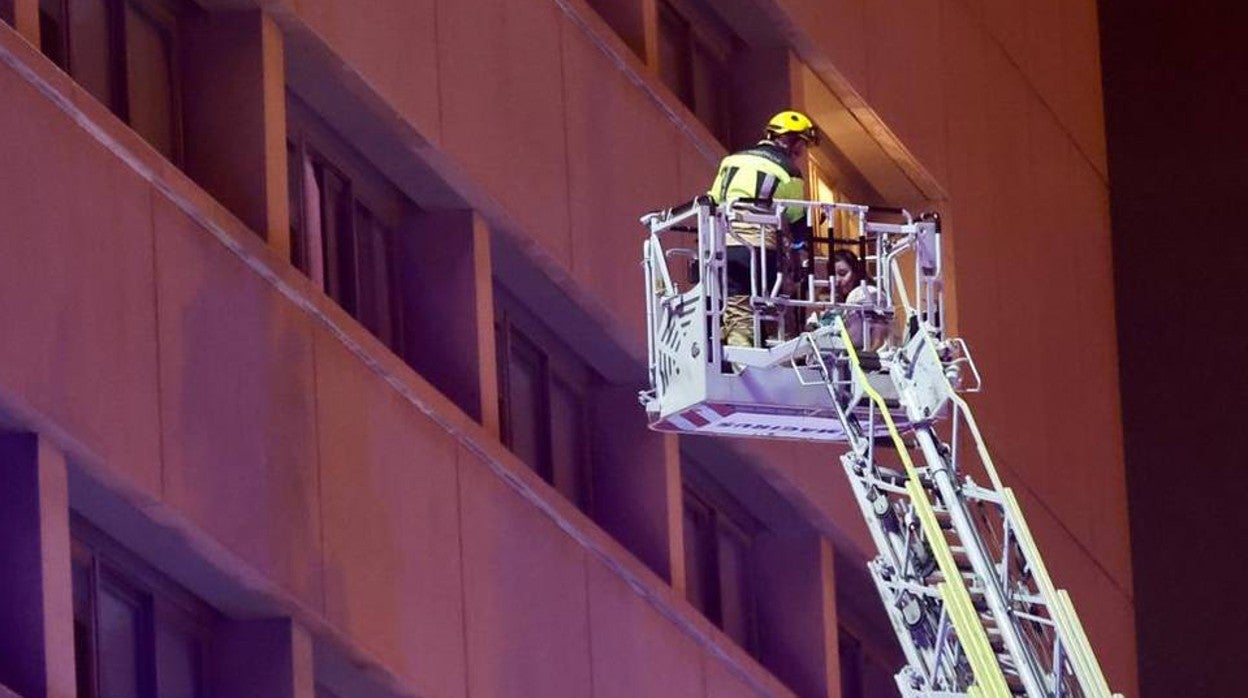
[753,533,840,698]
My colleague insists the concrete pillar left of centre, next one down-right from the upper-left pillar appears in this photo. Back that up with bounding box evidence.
[396,211,498,436]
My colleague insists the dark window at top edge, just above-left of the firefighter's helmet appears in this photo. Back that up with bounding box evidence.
[659,0,735,144]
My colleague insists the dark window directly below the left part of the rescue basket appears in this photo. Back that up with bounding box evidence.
[683,486,758,653]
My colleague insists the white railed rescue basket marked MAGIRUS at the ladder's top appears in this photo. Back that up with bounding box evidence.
[641,197,940,442]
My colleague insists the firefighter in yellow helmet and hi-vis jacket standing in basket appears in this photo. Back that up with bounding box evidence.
[708,110,819,357]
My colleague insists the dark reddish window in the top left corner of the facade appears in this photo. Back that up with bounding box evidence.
[39,0,182,162]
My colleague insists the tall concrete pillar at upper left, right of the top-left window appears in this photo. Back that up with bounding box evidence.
[180,10,291,258]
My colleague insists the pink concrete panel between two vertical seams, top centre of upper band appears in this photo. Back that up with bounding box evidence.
[439,0,572,266]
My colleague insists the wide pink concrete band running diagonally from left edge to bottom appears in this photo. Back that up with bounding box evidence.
[0,20,787,698]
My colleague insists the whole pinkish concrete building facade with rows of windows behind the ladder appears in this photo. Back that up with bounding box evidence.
[0,0,1137,698]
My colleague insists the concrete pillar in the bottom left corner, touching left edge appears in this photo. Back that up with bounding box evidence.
[0,433,75,698]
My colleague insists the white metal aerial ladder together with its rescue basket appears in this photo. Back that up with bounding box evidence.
[641,199,1111,698]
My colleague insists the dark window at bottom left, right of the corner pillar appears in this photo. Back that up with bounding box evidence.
[72,518,216,698]
